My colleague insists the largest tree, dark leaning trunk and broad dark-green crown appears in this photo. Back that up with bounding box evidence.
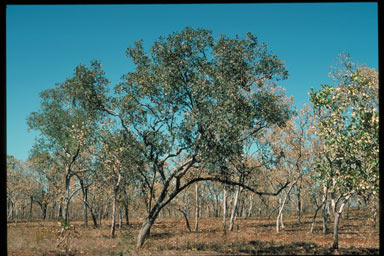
[61,28,290,247]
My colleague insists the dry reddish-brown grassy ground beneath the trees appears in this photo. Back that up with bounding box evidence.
[7,210,379,256]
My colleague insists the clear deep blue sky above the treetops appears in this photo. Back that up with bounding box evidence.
[6,3,378,160]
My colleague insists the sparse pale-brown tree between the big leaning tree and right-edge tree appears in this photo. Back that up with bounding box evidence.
[262,106,317,233]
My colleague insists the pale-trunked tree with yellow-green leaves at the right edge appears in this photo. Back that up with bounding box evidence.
[310,55,379,249]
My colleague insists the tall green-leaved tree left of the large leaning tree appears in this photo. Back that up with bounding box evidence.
[27,62,108,222]
